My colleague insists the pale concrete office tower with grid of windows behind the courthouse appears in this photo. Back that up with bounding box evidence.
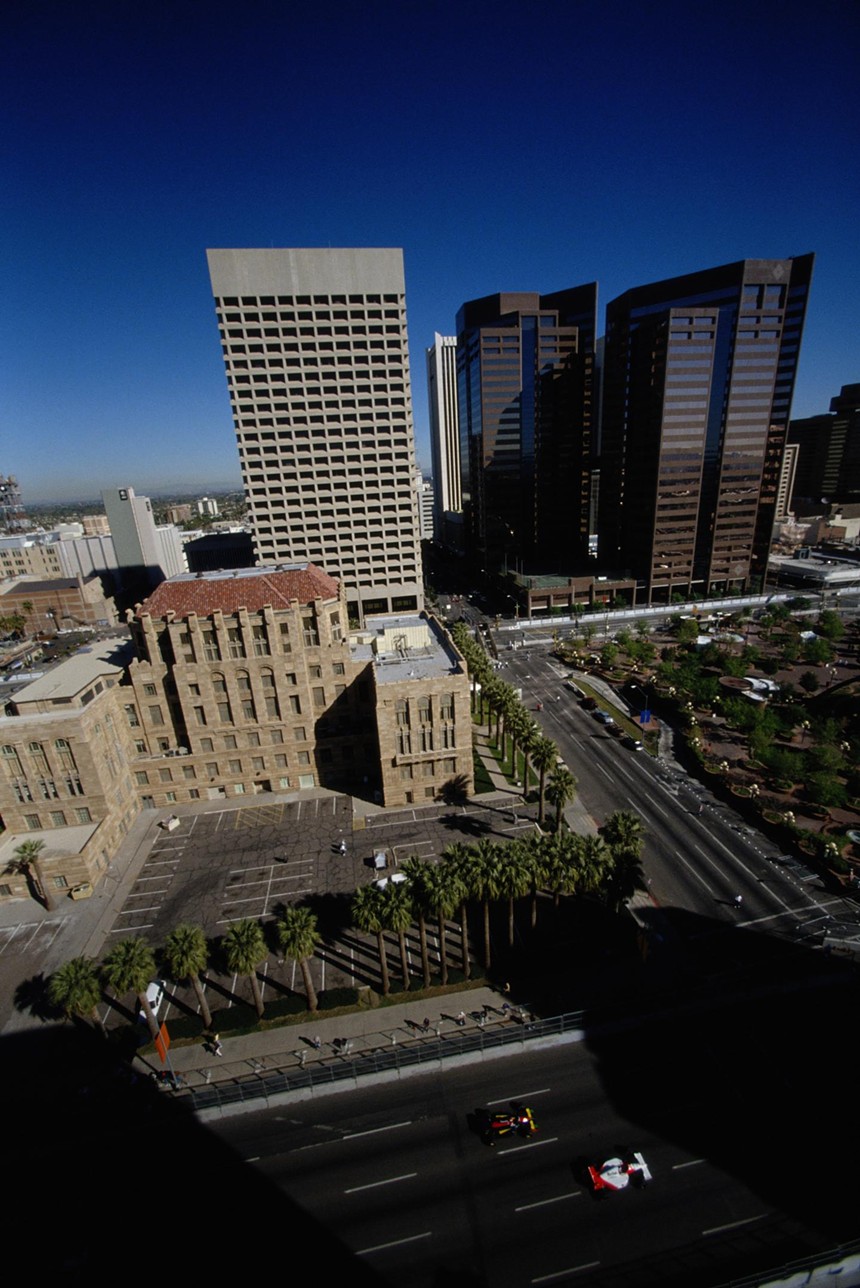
[206,250,422,620]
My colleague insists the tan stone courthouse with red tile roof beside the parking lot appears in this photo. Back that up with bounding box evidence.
[0,563,474,899]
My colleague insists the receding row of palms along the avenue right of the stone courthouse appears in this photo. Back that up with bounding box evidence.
[451,622,577,831]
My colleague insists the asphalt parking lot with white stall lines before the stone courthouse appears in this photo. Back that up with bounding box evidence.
[0,777,533,1027]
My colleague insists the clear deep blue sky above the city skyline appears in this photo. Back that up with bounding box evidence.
[0,0,860,500]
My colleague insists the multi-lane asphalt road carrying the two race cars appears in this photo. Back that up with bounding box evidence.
[214,1012,856,1288]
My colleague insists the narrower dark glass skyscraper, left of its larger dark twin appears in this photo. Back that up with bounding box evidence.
[457,292,597,573]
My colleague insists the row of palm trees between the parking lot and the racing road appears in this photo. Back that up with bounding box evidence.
[49,811,644,1038]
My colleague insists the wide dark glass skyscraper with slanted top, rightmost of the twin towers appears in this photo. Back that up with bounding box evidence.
[599,255,814,603]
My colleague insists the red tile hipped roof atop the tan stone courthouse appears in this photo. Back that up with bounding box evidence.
[135,564,337,618]
